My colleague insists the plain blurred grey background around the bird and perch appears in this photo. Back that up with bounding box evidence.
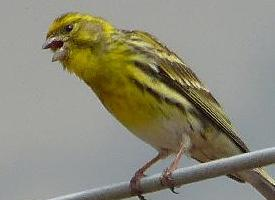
[0,0,275,200]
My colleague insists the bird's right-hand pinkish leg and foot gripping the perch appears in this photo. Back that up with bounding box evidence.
[160,143,186,194]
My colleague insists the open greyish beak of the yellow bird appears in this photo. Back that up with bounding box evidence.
[42,36,68,62]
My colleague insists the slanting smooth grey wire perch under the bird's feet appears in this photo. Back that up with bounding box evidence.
[48,147,275,200]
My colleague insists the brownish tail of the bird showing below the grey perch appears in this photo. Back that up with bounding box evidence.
[240,168,275,200]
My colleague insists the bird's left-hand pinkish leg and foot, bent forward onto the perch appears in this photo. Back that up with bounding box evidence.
[130,149,168,200]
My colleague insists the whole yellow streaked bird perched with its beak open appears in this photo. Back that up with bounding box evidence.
[42,12,275,200]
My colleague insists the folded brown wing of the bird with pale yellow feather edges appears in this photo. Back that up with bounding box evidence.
[159,57,249,152]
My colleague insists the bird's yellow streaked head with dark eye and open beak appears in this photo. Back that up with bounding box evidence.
[42,13,115,62]
